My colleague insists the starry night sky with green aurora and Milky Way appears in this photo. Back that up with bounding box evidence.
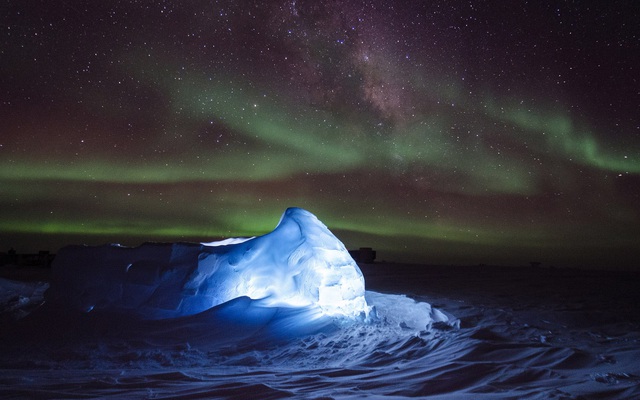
[0,0,640,268]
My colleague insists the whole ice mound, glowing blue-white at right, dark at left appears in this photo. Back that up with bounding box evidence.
[47,208,369,319]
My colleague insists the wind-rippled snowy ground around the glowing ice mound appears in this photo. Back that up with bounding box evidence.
[0,263,640,400]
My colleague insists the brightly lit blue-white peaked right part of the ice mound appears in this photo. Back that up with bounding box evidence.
[195,208,369,316]
